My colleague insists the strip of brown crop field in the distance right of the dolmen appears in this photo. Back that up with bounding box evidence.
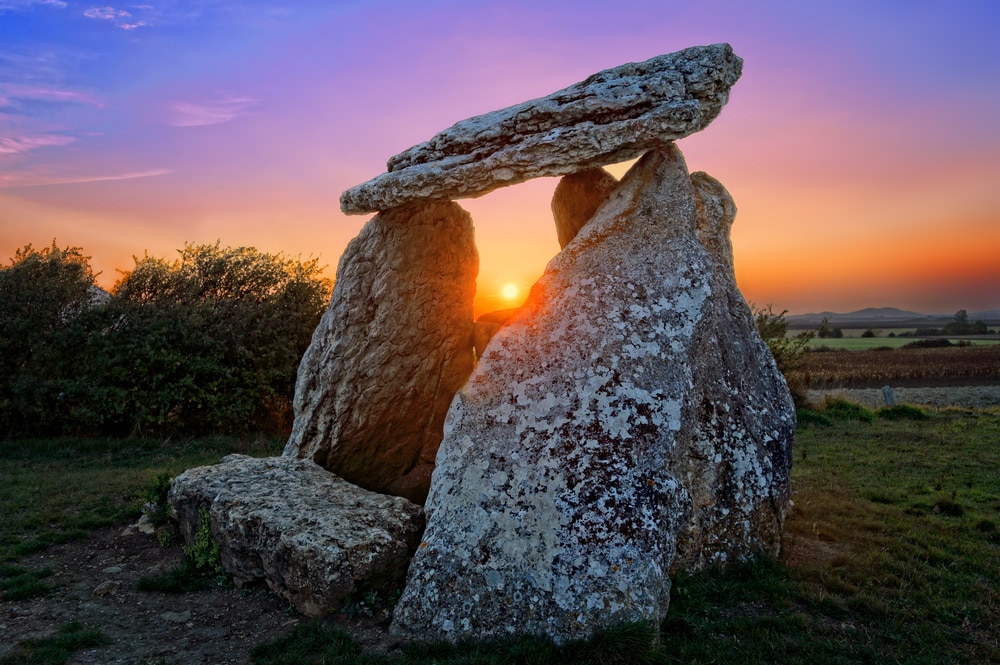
[792,340,1000,390]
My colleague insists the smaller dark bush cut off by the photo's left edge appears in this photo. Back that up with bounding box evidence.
[0,240,102,434]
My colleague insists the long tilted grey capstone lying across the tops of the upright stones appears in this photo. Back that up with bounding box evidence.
[340,44,743,214]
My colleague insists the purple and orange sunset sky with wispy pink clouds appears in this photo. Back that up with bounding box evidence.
[0,0,1000,313]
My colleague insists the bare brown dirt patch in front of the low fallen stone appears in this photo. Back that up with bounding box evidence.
[0,527,391,665]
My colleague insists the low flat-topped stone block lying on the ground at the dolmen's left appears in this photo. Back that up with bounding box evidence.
[170,455,424,616]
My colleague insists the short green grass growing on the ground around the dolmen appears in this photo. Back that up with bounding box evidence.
[0,402,1000,665]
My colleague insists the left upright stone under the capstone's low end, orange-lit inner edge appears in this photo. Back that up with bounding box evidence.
[284,202,478,492]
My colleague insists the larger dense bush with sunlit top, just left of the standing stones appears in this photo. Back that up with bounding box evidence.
[83,242,331,434]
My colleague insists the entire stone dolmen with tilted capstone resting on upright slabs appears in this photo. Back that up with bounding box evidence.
[172,44,795,641]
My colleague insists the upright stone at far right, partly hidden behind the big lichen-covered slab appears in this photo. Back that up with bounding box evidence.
[670,172,795,570]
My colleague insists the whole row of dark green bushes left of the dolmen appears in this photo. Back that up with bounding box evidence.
[0,241,332,438]
